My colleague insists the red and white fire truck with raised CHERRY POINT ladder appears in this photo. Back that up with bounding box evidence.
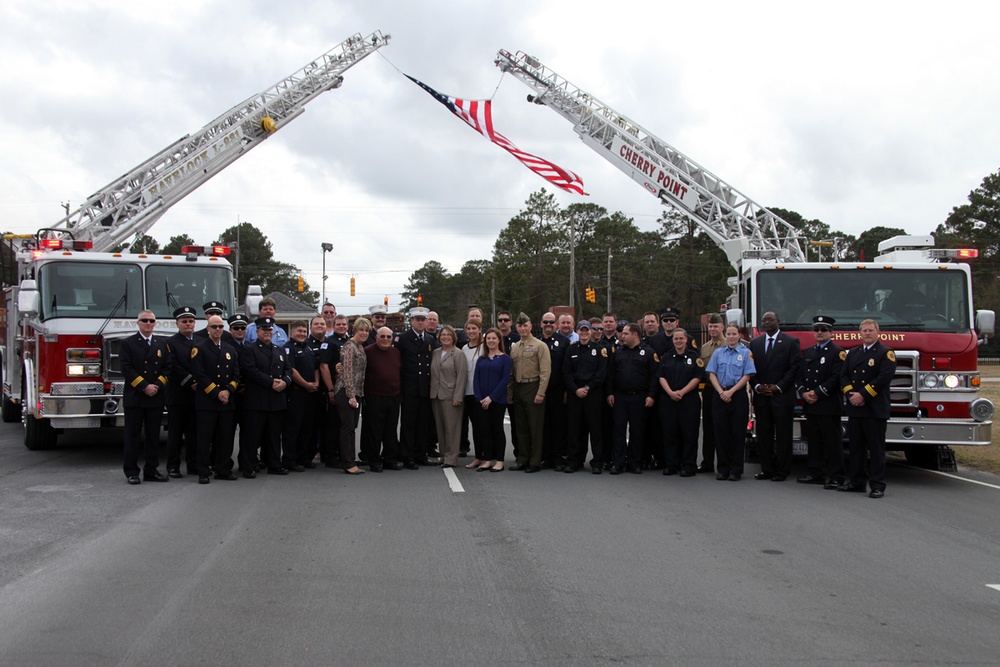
[495,50,995,469]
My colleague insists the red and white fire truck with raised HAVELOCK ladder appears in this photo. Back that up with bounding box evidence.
[0,32,389,449]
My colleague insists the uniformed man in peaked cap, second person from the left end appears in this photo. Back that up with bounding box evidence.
[167,306,198,478]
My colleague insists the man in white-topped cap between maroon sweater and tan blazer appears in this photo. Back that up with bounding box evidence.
[393,307,435,470]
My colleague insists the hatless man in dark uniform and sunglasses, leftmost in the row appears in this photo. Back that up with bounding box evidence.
[118,310,170,484]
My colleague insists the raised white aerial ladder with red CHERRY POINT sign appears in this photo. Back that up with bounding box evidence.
[495,49,805,272]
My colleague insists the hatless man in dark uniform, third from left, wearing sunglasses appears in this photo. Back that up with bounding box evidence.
[191,315,240,484]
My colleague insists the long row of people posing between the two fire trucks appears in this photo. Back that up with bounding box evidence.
[119,299,895,498]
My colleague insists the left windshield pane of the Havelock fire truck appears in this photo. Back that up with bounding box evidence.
[38,262,142,320]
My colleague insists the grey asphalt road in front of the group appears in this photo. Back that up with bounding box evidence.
[0,424,1000,666]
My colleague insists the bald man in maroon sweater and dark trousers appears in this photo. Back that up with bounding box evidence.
[361,327,403,472]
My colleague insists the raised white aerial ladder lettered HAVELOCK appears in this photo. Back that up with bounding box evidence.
[46,31,390,252]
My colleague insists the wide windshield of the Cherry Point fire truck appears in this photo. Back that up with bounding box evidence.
[754,266,971,333]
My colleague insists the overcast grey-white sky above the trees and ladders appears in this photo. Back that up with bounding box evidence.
[0,0,1000,313]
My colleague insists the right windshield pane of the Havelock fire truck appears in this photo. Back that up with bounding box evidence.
[146,264,234,319]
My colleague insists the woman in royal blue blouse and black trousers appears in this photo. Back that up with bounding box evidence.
[473,327,512,472]
